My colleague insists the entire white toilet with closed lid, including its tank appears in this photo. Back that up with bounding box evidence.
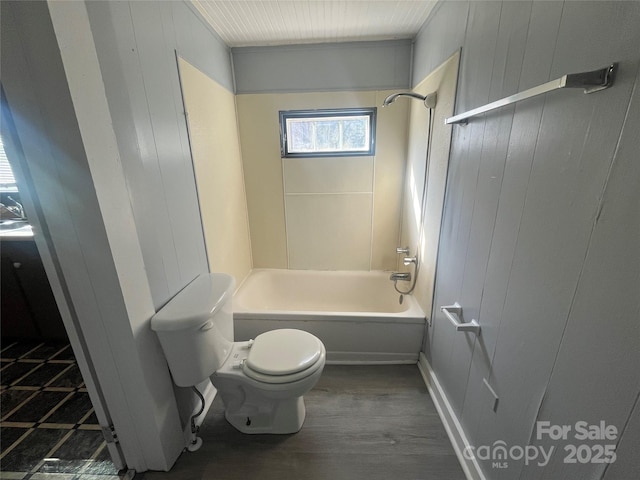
[151,273,326,434]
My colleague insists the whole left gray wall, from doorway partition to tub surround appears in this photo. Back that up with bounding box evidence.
[2,1,238,471]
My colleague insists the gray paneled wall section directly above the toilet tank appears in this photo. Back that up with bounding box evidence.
[87,1,232,308]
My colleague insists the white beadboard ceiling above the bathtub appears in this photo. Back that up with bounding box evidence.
[190,0,436,47]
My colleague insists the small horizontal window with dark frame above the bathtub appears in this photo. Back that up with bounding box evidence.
[280,107,377,157]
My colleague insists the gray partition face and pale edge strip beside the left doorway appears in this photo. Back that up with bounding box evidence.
[0,1,191,471]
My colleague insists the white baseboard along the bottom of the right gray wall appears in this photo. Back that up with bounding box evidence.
[418,352,486,480]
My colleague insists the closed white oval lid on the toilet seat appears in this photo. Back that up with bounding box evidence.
[245,328,322,375]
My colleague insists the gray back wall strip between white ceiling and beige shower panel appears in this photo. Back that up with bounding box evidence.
[232,40,411,94]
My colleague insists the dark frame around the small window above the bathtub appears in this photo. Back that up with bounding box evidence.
[279,107,378,158]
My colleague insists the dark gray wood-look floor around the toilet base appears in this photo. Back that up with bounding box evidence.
[136,365,465,480]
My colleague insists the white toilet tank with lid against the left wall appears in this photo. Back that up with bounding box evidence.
[151,273,235,387]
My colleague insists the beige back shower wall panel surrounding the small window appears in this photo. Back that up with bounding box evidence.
[236,90,408,270]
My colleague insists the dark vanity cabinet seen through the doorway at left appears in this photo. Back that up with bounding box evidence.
[0,238,67,340]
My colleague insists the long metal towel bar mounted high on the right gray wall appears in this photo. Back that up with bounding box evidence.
[444,63,617,125]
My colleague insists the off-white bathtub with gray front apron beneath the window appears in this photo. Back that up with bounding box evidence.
[233,269,425,364]
